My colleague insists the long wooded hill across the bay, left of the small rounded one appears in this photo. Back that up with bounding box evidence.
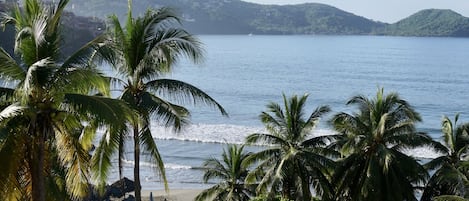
[70,0,385,34]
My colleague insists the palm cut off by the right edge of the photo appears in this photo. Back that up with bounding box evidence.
[421,114,469,200]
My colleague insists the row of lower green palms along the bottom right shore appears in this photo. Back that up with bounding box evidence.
[196,92,469,201]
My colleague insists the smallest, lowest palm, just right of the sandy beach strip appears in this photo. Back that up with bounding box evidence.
[195,145,253,201]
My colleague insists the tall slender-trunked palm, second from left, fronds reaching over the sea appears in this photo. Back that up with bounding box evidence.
[93,0,226,201]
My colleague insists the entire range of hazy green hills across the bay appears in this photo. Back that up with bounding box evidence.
[69,0,469,37]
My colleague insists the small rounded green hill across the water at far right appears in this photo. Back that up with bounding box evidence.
[383,9,469,37]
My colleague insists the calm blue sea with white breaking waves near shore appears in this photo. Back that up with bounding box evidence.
[104,35,469,189]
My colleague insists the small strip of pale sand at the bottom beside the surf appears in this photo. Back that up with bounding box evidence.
[142,189,203,201]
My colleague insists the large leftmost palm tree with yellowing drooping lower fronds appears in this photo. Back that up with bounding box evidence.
[0,0,129,201]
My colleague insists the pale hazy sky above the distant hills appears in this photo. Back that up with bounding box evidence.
[244,0,469,23]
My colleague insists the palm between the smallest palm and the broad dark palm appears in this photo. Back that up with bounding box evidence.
[246,95,336,200]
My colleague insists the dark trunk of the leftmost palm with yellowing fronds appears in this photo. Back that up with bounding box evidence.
[29,135,46,201]
